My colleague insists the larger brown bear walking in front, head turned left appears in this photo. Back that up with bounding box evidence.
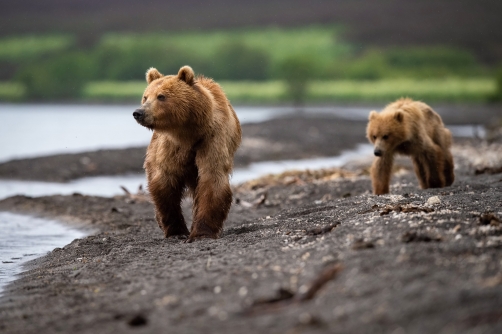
[133,66,241,242]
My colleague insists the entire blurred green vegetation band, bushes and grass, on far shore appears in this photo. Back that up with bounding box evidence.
[0,26,496,104]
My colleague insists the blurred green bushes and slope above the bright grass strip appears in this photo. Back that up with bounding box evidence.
[0,25,500,100]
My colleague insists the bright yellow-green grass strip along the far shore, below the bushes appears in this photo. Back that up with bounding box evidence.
[78,78,496,103]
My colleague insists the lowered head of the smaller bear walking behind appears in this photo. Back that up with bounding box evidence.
[366,110,409,157]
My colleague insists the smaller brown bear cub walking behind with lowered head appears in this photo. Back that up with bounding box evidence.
[366,98,455,195]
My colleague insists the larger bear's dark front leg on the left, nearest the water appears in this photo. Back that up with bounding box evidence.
[148,176,190,238]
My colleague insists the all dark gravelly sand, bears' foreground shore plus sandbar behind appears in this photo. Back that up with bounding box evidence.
[0,108,502,333]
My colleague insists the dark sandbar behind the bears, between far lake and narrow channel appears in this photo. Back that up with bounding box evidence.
[0,104,502,182]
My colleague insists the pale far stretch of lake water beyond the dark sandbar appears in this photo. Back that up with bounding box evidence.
[0,104,483,162]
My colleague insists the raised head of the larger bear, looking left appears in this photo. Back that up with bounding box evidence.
[133,66,211,131]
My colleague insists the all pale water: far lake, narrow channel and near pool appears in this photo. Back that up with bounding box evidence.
[0,104,484,293]
